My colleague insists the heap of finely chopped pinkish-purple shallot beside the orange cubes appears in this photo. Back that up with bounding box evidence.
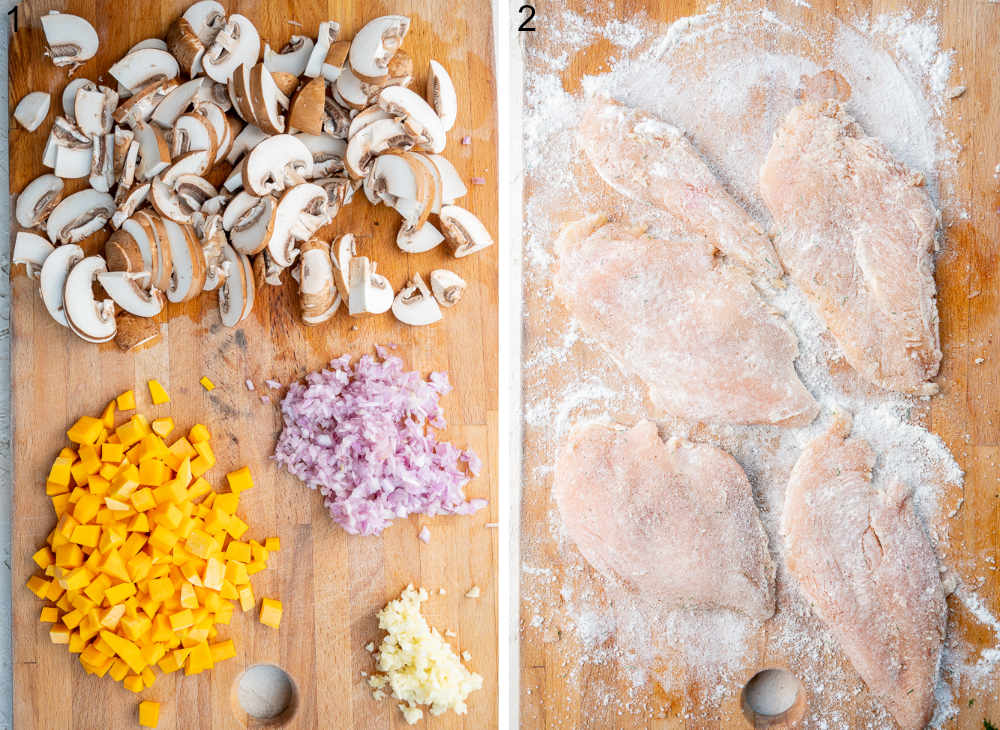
[274,347,486,535]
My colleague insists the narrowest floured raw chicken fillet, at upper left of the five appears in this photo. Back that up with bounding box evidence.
[577,98,782,281]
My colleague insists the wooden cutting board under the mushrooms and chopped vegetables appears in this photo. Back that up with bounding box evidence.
[4,0,497,730]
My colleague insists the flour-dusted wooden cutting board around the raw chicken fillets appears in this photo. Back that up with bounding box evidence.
[520,0,1000,730]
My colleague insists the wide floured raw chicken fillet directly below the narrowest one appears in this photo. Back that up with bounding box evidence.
[554,215,817,425]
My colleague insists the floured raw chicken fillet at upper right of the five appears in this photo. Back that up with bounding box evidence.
[760,95,941,395]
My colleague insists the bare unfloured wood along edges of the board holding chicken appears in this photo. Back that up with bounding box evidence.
[519,0,1000,730]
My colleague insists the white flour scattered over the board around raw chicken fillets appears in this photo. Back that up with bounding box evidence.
[522,0,1000,729]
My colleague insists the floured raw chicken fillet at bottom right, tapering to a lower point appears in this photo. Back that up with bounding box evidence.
[782,416,947,730]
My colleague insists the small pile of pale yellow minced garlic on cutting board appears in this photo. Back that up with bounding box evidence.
[368,585,483,725]
